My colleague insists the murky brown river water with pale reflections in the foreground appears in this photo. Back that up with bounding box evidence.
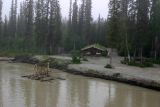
[0,62,160,107]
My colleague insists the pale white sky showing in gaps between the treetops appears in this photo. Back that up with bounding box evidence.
[2,0,109,20]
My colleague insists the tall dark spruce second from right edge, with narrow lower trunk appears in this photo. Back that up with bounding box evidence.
[136,0,149,63]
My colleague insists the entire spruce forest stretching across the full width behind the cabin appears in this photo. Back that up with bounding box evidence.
[0,0,160,59]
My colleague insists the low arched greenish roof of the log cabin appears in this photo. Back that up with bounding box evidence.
[81,44,107,51]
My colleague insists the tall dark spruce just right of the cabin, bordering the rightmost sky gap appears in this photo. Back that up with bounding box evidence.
[107,0,120,65]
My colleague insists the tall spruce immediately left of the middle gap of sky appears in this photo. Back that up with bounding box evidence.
[47,0,61,54]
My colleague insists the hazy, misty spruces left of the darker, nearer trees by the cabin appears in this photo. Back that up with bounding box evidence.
[0,0,105,54]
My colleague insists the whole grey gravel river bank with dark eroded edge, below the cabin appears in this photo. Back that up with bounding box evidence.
[7,56,160,91]
